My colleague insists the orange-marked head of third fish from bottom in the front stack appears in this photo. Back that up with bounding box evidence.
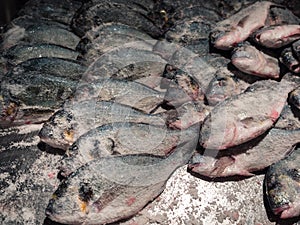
[39,110,75,150]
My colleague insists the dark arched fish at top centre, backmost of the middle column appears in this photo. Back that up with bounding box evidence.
[72,1,162,38]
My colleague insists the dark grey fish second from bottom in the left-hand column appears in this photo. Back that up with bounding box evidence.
[7,57,87,80]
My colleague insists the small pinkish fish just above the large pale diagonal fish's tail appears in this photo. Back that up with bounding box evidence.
[231,43,280,79]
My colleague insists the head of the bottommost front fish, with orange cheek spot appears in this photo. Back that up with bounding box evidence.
[45,178,93,224]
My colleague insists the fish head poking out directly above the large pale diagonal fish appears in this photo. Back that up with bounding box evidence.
[205,69,249,106]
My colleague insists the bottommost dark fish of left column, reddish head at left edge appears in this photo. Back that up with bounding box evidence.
[0,71,77,127]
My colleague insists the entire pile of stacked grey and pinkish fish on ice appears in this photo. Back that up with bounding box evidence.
[0,0,300,225]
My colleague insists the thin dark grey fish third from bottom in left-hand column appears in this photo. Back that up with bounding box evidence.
[4,44,79,65]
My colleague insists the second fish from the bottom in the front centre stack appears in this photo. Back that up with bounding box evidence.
[59,122,197,177]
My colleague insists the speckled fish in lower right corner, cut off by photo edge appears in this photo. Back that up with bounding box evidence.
[265,148,300,219]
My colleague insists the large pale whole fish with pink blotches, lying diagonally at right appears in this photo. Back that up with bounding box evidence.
[200,74,300,150]
